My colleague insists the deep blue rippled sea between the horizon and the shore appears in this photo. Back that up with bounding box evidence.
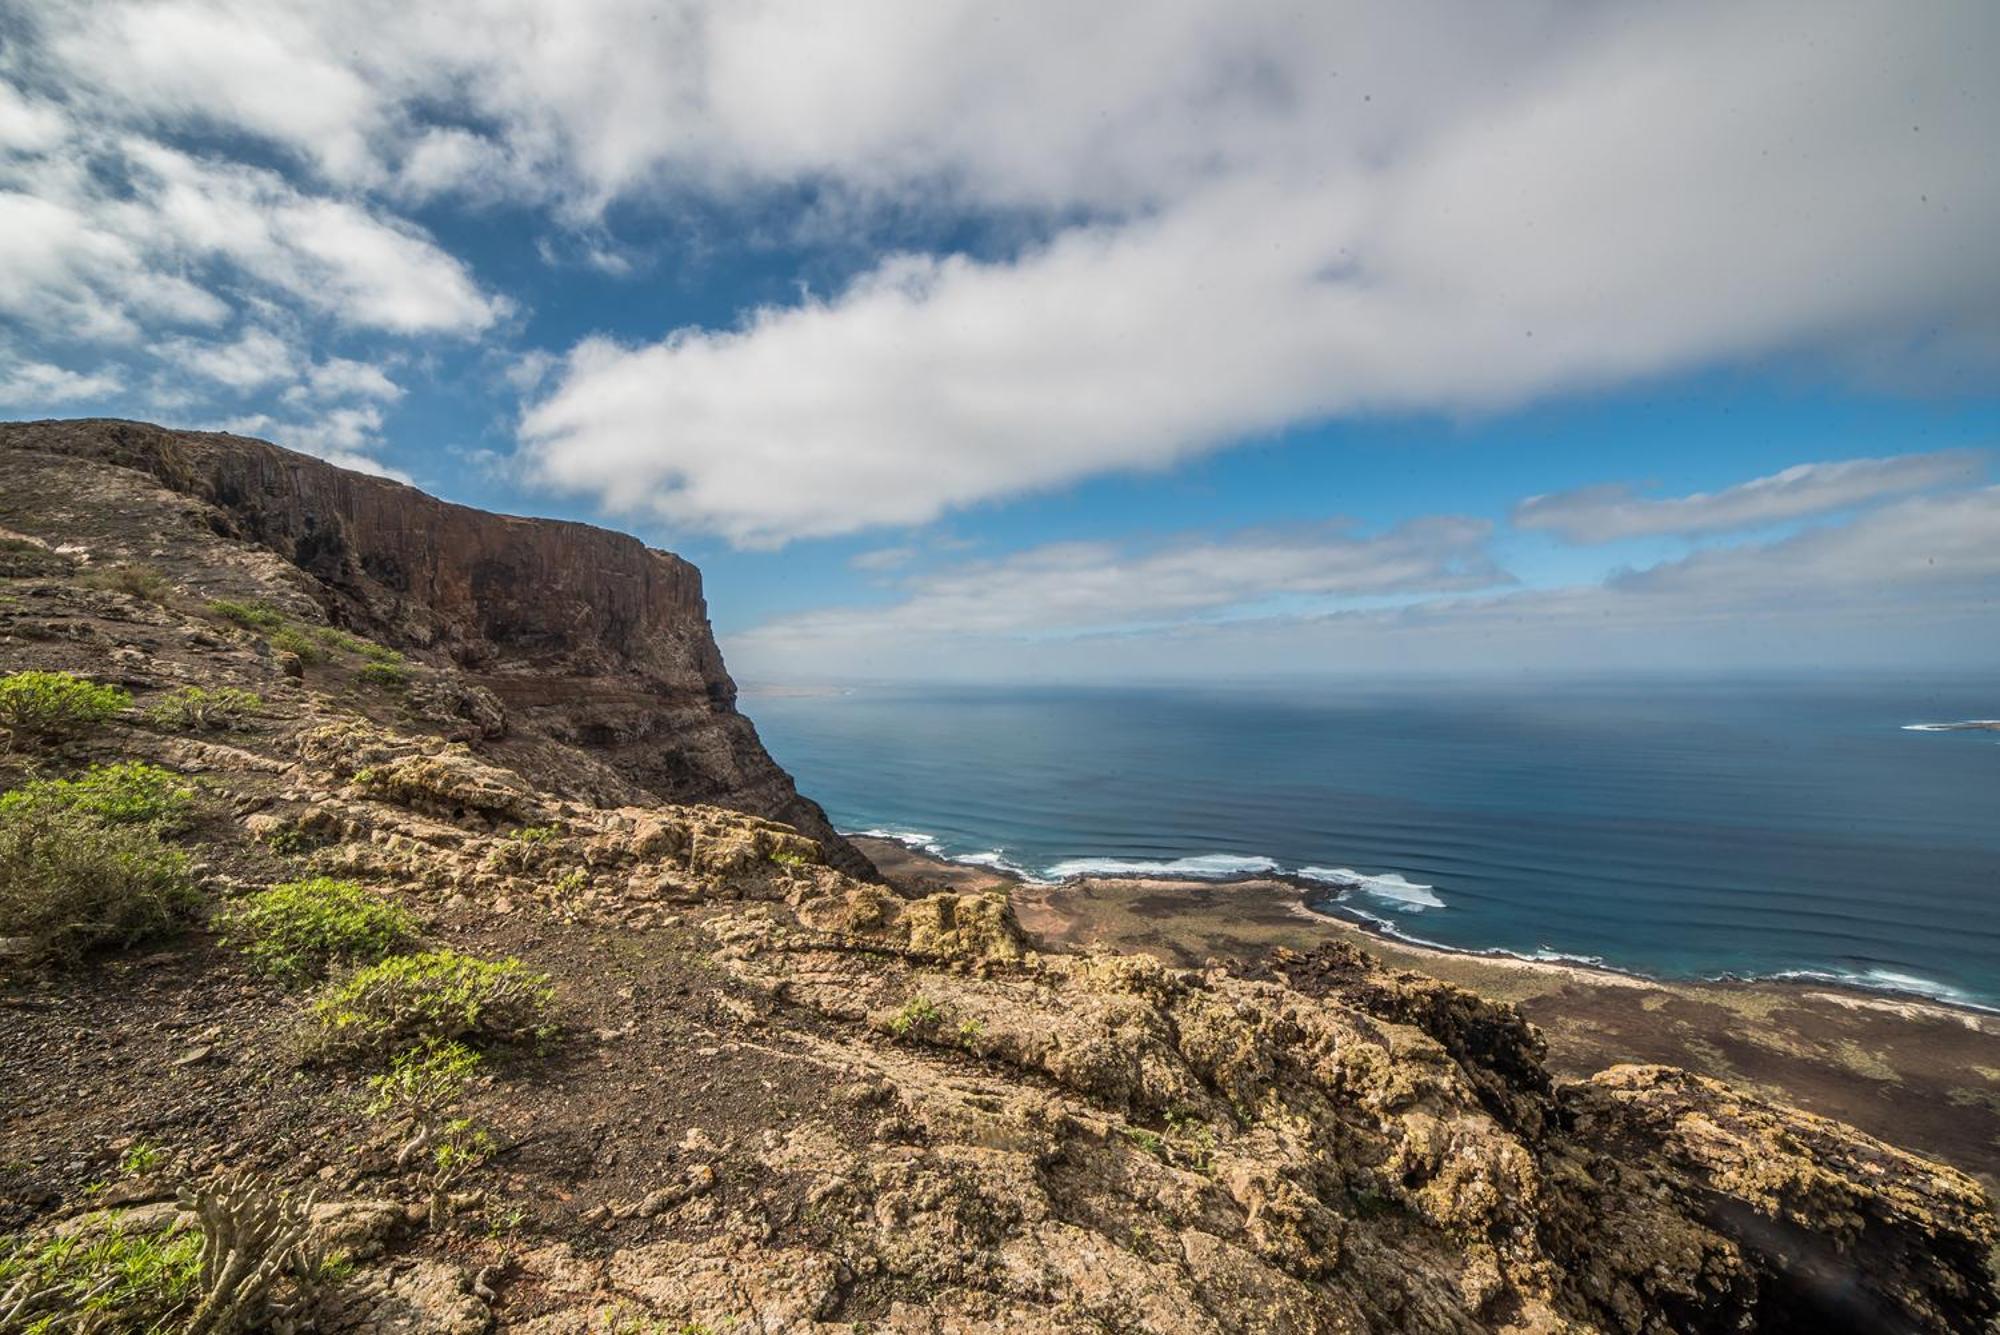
[744,679,2000,1005]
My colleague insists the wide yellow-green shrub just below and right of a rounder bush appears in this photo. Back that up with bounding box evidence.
[306,949,556,1055]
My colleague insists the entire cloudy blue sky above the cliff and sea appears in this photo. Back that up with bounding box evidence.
[0,0,2000,683]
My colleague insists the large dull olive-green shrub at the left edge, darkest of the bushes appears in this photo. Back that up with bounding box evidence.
[0,803,200,959]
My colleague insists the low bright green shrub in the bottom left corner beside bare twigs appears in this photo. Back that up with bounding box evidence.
[0,1219,202,1335]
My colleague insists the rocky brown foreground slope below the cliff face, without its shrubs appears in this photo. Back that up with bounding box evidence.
[0,419,2000,1335]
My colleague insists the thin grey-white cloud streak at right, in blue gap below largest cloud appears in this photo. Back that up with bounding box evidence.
[1512,450,1986,542]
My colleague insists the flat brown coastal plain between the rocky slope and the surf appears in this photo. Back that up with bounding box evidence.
[856,837,2000,1187]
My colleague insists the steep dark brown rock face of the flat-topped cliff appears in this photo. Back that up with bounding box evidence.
[0,420,874,879]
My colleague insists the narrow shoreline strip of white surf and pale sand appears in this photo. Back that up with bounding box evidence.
[842,829,2000,1035]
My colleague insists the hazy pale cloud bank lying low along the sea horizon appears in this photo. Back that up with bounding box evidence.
[728,488,2000,679]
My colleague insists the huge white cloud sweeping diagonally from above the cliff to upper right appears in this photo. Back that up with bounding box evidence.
[522,4,2000,546]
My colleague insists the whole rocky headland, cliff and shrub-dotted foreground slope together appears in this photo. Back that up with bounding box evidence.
[0,424,2000,1335]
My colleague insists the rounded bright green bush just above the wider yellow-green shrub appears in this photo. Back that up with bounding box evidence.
[222,875,418,983]
